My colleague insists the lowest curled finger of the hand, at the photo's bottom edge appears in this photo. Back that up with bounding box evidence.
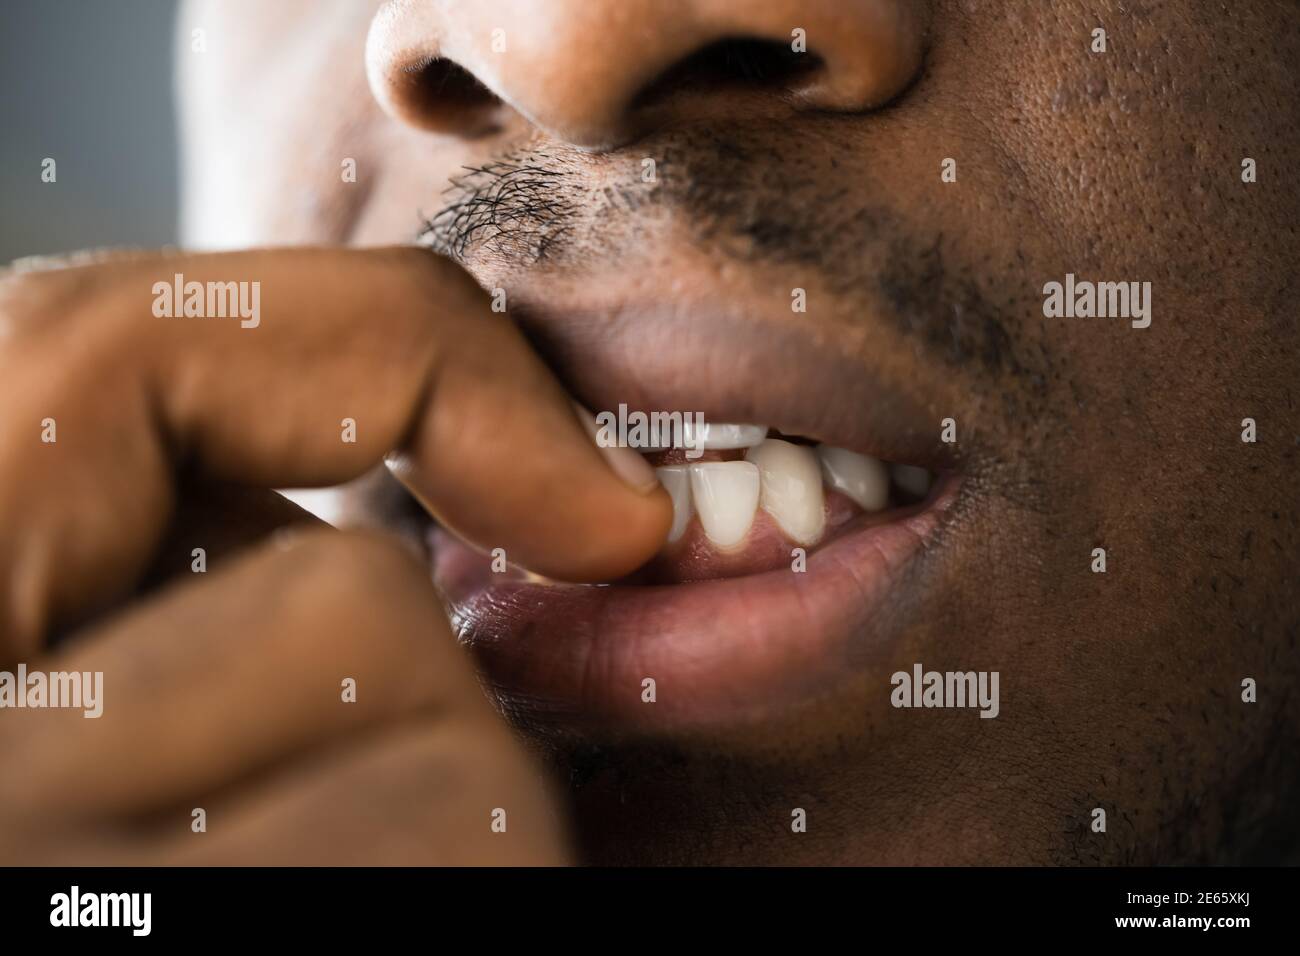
[144,718,568,866]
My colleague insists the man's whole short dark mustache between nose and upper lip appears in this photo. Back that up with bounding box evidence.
[416,127,1050,390]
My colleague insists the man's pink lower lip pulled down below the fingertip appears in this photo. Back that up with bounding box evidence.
[433,484,956,734]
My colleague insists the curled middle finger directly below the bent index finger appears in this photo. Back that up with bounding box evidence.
[0,522,498,825]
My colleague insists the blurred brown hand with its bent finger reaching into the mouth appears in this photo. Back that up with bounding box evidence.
[0,250,671,864]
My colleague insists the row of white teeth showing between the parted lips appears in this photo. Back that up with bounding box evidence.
[655,424,930,548]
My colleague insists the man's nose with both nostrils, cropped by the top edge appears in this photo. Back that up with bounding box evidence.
[367,0,928,150]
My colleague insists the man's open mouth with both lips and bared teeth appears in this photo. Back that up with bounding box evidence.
[426,287,962,736]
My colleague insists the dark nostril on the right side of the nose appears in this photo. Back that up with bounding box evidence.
[631,38,824,109]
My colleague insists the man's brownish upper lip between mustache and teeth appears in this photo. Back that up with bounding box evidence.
[512,295,961,472]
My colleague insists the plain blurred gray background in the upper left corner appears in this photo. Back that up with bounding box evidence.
[0,0,179,263]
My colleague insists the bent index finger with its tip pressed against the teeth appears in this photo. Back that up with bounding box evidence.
[0,248,671,659]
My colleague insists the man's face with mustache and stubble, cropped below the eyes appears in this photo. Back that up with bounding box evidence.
[181,0,1300,862]
